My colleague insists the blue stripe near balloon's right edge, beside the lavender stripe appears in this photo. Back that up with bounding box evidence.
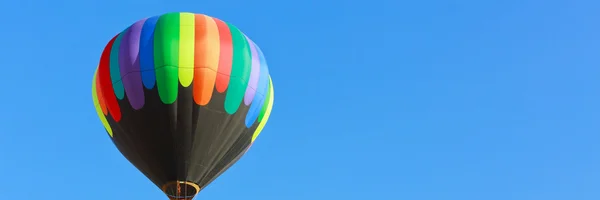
[246,44,269,128]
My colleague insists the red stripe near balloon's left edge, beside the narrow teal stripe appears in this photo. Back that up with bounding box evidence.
[98,36,121,122]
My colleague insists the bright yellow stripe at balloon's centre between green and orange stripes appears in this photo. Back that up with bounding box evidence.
[179,13,196,87]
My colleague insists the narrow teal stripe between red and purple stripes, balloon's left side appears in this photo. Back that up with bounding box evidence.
[110,28,129,100]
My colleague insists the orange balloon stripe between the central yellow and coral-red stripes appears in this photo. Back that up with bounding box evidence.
[193,14,220,106]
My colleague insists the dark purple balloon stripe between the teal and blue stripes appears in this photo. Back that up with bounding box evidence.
[119,19,146,110]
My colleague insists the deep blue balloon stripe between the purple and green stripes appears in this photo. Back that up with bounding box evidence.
[140,16,160,89]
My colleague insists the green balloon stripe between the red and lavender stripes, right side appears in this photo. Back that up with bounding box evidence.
[225,23,252,114]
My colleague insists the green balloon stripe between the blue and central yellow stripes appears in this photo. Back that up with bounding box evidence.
[154,13,179,104]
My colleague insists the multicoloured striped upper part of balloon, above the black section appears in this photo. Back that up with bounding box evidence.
[93,13,272,130]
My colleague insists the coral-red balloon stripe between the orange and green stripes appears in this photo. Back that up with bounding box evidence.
[212,18,233,93]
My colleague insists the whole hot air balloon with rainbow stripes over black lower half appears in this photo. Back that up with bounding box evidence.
[92,12,274,200]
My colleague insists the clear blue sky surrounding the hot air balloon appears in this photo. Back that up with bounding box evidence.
[0,0,600,200]
